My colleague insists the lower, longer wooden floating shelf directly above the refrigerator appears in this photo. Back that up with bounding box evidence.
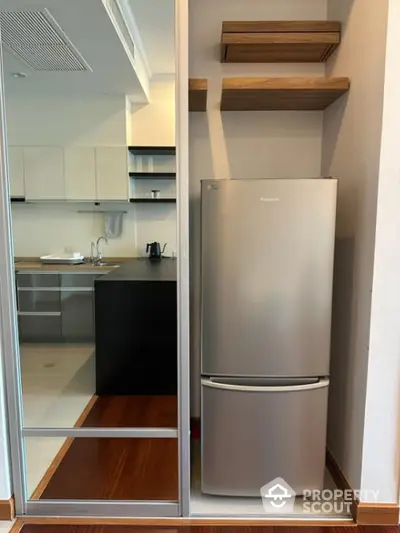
[221,77,350,111]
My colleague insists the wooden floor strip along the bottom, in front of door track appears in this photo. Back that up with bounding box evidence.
[15,524,399,533]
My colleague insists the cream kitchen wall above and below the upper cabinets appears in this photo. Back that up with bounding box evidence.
[6,88,176,257]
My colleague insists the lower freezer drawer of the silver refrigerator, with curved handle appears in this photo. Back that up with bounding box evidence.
[201,378,329,497]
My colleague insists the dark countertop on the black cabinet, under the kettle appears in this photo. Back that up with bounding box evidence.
[96,257,176,284]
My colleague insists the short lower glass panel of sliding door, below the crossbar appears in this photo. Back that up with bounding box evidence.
[25,437,178,501]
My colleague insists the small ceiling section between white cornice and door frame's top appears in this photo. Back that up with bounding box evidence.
[128,0,173,77]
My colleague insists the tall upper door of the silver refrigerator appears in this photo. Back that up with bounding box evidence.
[202,179,337,376]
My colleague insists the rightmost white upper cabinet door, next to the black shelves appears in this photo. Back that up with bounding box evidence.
[96,147,129,200]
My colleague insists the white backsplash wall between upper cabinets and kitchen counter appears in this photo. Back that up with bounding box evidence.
[12,203,176,257]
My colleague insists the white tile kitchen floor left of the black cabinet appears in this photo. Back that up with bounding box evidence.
[20,344,95,496]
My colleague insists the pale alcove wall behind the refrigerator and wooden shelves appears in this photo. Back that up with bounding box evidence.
[189,0,327,416]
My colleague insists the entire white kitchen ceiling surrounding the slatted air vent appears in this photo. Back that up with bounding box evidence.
[0,0,174,97]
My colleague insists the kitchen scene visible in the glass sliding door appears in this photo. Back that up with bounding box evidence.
[0,0,188,516]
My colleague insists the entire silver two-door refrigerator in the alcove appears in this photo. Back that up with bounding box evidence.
[201,179,337,496]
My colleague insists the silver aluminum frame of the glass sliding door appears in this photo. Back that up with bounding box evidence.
[0,0,190,517]
